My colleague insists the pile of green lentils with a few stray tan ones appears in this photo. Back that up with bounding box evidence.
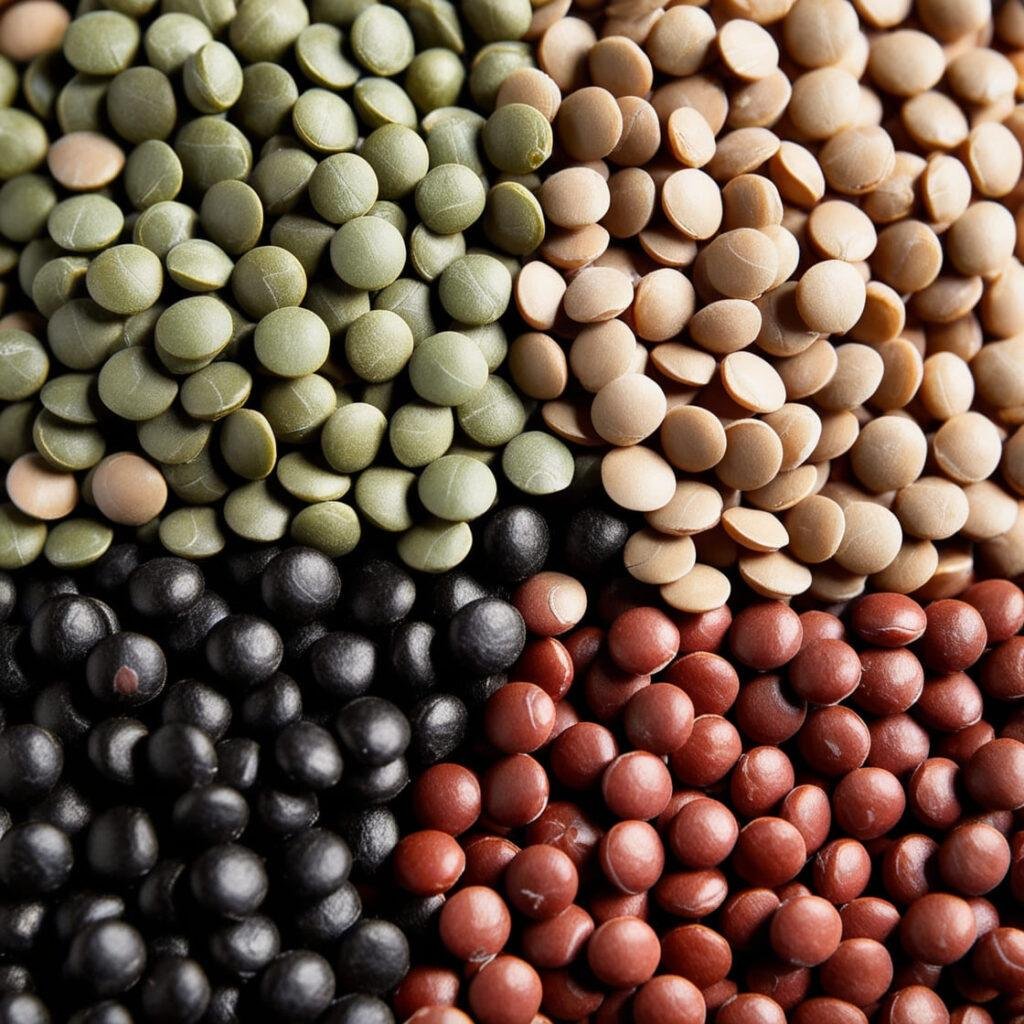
[0,0,573,571]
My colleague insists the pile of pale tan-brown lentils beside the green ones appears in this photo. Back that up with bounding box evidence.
[499,0,1024,611]
